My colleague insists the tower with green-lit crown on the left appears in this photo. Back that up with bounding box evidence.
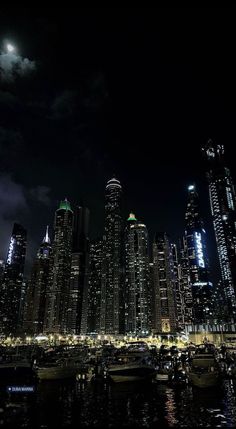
[44,199,73,333]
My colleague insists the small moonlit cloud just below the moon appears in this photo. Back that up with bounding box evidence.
[0,52,36,83]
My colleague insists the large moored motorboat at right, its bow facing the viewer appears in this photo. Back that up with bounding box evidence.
[188,344,219,387]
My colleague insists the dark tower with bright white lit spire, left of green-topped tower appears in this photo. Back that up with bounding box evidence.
[23,227,52,334]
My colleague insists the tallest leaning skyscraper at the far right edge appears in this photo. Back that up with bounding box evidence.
[202,140,236,321]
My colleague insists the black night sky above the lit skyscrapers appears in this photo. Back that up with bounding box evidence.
[0,8,236,278]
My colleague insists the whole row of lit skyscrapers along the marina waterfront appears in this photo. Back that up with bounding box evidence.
[0,140,236,336]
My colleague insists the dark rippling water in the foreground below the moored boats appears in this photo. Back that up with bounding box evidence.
[0,380,236,428]
